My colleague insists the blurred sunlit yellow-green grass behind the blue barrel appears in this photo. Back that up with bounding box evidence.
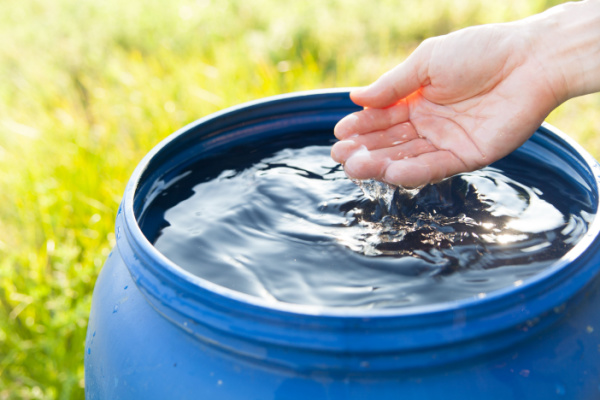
[0,0,600,400]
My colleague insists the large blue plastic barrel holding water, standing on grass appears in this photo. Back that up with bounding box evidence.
[85,90,600,400]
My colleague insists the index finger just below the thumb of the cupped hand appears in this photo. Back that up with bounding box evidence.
[333,101,408,140]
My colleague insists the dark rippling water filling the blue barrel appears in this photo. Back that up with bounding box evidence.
[140,146,591,308]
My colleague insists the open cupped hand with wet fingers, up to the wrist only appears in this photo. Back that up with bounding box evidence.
[332,23,557,187]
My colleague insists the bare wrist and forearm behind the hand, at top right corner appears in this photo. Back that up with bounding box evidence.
[517,0,600,102]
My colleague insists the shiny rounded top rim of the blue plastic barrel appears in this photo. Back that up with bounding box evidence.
[117,88,600,321]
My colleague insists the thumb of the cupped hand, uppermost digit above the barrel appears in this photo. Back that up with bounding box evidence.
[350,42,430,108]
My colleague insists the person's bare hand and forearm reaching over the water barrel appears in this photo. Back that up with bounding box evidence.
[331,0,600,187]
